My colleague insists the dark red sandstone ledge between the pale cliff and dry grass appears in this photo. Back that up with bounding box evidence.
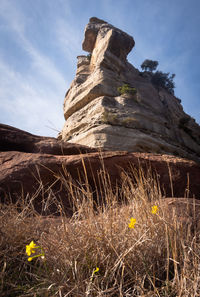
[0,125,200,214]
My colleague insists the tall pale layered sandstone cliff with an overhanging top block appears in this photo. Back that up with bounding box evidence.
[59,18,200,159]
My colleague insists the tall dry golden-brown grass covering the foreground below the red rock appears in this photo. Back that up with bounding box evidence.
[0,163,200,297]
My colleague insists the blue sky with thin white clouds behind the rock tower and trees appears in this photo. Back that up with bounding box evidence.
[0,0,200,136]
